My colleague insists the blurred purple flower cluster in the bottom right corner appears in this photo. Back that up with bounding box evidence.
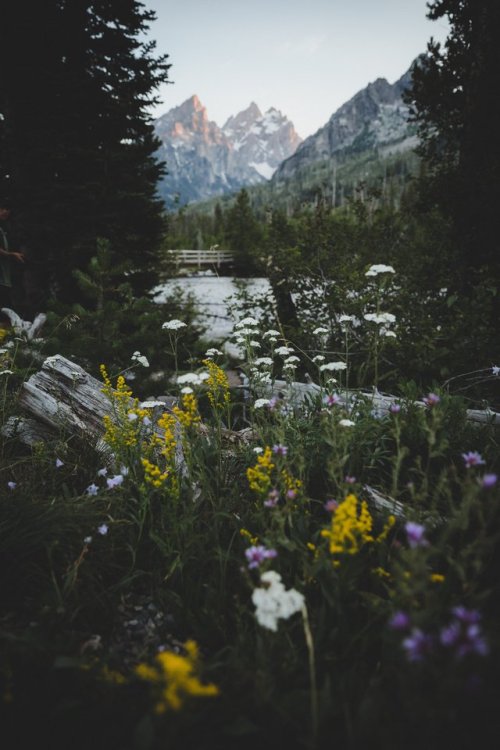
[388,605,489,662]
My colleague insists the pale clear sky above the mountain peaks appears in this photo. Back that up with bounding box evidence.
[142,0,448,138]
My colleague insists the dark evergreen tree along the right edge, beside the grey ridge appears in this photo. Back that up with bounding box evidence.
[407,0,500,282]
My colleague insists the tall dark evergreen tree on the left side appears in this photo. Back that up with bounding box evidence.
[0,0,169,312]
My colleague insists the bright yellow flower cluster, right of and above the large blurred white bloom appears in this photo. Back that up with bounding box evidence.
[321,495,396,555]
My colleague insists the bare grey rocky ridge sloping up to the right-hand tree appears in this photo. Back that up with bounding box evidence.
[272,68,417,186]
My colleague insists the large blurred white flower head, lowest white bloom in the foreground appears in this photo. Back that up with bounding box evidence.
[252,570,304,632]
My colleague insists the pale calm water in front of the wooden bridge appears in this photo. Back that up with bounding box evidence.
[154,275,270,342]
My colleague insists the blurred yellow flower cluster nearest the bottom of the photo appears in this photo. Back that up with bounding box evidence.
[135,641,219,714]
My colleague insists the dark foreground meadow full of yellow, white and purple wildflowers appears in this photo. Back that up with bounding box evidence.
[0,264,500,750]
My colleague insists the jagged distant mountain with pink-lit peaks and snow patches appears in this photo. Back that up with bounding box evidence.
[155,96,301,207]
